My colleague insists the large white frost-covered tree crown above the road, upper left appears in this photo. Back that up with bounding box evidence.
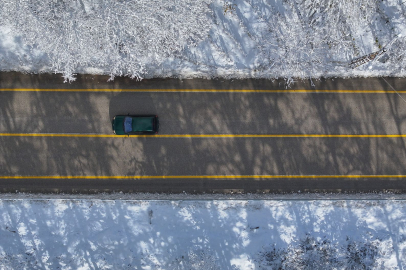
[0,0,210,81]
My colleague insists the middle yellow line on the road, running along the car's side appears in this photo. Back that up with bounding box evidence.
[0,133,406,138]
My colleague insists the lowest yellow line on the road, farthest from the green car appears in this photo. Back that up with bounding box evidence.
[0,174,406,179]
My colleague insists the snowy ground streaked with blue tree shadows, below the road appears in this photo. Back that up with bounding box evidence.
[0,194,406,270]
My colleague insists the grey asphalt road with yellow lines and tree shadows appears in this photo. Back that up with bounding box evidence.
[0,73,406,193]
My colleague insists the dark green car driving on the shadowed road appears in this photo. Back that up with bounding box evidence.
[112,115,159,135]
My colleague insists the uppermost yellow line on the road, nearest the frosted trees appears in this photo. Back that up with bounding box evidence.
[0,88,406,94]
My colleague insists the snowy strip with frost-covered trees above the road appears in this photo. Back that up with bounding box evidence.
[0,0,406,81]
